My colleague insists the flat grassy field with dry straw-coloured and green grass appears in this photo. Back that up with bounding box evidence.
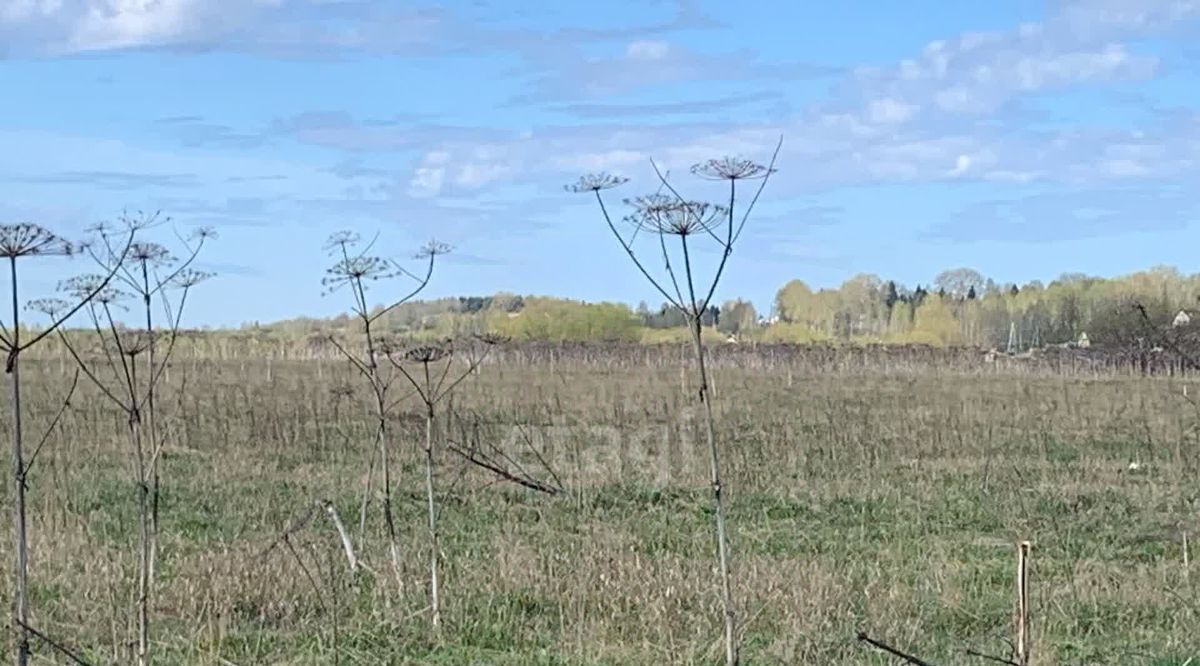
[0,348,1200,666]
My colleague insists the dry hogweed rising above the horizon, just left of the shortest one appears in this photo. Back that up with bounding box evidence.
[322,232,450,607]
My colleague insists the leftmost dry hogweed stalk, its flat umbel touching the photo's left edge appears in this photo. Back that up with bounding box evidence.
[0,223,136,666]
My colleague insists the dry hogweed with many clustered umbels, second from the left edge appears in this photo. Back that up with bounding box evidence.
[49,216,212,666]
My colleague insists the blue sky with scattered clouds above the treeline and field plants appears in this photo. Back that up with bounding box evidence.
[0,0,1200,325]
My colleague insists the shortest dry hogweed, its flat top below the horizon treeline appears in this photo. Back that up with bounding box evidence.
[388,335,500,628]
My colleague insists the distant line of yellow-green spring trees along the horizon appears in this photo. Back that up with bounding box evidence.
[255,266,1200,349]
